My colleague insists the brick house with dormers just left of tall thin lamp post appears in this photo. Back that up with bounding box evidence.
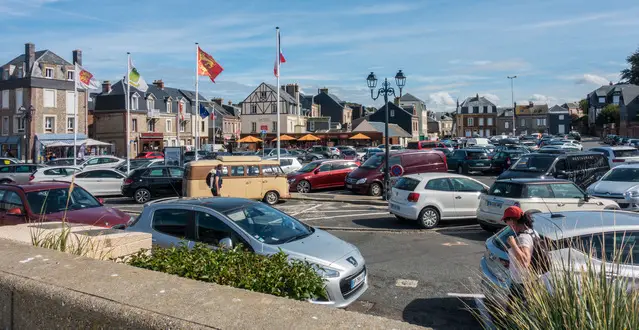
[456,95,497,137]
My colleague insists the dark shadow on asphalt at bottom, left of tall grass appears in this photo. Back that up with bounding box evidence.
[402,297,481,330]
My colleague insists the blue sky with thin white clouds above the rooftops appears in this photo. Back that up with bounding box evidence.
[0,0,639,111]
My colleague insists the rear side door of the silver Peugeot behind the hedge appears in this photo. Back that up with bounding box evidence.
[151,206,195,248]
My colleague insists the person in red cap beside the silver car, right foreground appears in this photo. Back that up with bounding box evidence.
[501,206,535,301]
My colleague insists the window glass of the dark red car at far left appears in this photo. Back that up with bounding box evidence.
[26,186,102,214]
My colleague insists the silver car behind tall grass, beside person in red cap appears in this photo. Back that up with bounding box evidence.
[480,211,639,297]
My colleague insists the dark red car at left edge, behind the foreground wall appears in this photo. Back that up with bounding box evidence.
[0,182,131,229]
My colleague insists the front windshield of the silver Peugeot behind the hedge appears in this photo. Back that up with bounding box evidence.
[226,203,314,244]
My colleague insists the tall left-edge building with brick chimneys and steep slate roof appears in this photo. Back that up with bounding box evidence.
[0,43,88,160]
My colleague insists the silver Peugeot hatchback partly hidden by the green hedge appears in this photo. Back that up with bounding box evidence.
[126,197,368,308]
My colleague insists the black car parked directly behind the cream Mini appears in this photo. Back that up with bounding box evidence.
[497,148,610,189]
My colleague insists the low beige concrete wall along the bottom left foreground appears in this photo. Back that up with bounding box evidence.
[0,239,430,329]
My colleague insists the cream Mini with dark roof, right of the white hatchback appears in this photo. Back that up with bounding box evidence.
[477,179,619,231]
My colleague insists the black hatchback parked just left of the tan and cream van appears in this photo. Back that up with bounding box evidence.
[122,166,184,204]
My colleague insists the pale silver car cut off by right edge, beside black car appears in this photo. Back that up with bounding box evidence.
[586,164,639,211]
